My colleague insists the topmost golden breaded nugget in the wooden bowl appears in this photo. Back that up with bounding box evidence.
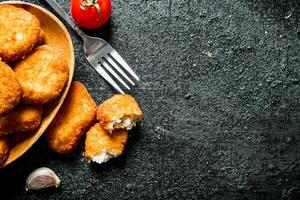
[0,4,41,62]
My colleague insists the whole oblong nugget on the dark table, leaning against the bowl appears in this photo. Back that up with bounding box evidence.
[46,81,97,153]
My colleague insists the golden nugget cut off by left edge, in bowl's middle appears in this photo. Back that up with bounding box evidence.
[0,61,22,115]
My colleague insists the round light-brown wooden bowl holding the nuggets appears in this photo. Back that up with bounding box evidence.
[0,1,74,168]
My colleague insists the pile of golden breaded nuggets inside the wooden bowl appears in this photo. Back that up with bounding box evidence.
[0,4,69,164]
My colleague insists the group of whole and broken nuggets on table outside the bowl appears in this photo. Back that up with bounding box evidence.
[46,81,143,164]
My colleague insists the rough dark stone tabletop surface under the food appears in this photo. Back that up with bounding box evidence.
[0,0,300,200]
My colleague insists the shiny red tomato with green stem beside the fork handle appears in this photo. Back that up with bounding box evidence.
[71,0,111,29]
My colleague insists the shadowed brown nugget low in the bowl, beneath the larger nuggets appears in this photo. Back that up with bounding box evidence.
[0,104,43,136]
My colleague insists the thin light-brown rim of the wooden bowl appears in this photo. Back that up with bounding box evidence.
[0,1,75,168]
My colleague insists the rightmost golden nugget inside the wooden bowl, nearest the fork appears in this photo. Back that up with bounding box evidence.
[14,45,69,104]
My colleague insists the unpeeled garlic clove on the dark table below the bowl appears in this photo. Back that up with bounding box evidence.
[25,167,60,191]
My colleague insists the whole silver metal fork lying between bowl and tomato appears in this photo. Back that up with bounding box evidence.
[45,0,140,94]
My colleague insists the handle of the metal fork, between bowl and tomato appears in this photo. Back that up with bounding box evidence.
[45,0,86,40]
